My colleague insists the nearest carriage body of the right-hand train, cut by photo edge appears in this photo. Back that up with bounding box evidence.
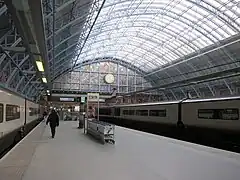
[182,97,240,131]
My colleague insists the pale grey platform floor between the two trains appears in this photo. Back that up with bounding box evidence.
[0,122,240,180]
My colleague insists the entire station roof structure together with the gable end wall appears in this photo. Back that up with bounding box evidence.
[0,0,240,100]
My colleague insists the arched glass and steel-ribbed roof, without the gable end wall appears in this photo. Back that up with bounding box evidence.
[0,0,240,100]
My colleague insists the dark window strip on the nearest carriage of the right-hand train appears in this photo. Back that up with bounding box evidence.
[198,109,239,120]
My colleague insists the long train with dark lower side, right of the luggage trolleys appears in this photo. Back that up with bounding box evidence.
[99,96,240,151]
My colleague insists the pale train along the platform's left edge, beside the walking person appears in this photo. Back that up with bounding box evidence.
[0,89,45,156]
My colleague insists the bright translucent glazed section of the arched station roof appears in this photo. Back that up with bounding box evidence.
[74,0,240,71]
